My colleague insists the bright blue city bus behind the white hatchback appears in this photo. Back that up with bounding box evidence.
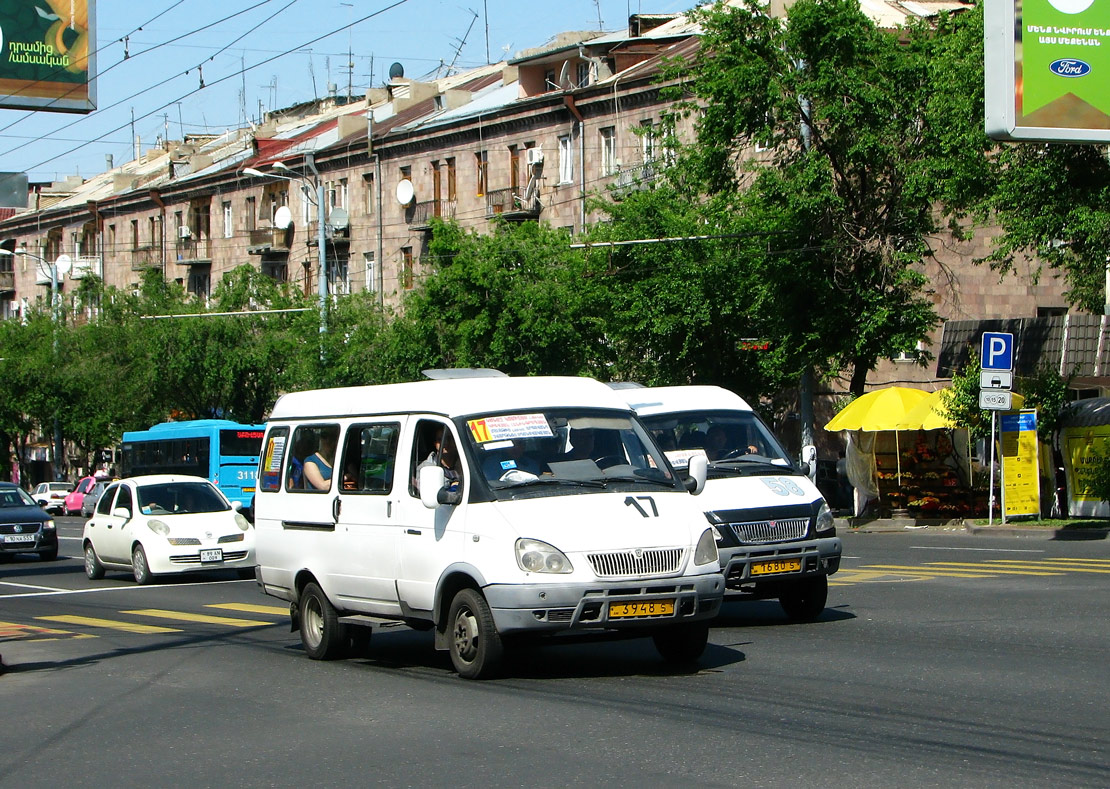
[121,419,265,510]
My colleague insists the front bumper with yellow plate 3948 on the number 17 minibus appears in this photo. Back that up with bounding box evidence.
[483,573,725,633]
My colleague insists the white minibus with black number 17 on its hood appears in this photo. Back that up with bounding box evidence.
[254,373,725,678]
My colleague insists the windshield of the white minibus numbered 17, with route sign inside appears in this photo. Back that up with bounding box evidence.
[460,408,677,500]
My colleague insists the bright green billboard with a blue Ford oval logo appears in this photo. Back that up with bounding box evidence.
[983,0,1110,142]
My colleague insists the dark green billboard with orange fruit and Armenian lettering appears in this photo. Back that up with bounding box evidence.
[0,0,97,112]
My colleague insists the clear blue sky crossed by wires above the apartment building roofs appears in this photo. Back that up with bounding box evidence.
[0,0,694,181]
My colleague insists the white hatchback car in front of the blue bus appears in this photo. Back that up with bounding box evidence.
[81,474,255,584]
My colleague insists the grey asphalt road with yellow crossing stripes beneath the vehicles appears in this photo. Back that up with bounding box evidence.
[0,518,1110,789]
